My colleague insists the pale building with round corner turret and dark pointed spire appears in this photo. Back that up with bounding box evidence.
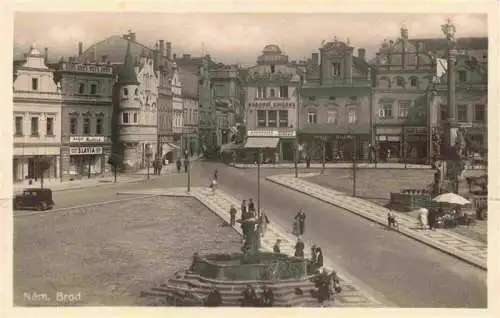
[115,40,158,170]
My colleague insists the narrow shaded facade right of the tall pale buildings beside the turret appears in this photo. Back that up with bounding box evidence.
[179,68,200,155]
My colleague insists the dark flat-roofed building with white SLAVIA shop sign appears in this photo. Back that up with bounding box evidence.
[55,60,114,179]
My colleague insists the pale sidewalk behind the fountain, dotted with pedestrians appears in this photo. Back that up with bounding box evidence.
[118,187,382,307]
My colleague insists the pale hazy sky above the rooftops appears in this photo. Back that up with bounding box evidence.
[14,12,488,66]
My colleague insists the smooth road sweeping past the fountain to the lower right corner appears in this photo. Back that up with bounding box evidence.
[13,162,487,308]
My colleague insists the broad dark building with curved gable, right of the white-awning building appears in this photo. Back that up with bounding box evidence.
[298,39,372,162]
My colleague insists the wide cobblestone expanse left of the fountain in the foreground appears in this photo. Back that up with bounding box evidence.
[13,197,240,306]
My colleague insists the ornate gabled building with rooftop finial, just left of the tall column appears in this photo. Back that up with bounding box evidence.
[372,27,436,163]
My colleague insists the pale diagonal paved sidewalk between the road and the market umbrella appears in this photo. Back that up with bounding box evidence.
[266,173,488,270]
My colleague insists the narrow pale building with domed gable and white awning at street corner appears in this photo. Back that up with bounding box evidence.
[244,45,301,161]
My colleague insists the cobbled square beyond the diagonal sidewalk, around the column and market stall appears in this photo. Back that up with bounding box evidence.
[306,169,488,243]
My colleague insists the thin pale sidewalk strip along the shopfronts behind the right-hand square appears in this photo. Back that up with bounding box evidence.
[229,162,488,170]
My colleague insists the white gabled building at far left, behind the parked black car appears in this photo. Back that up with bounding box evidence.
[13,45,61,182]
